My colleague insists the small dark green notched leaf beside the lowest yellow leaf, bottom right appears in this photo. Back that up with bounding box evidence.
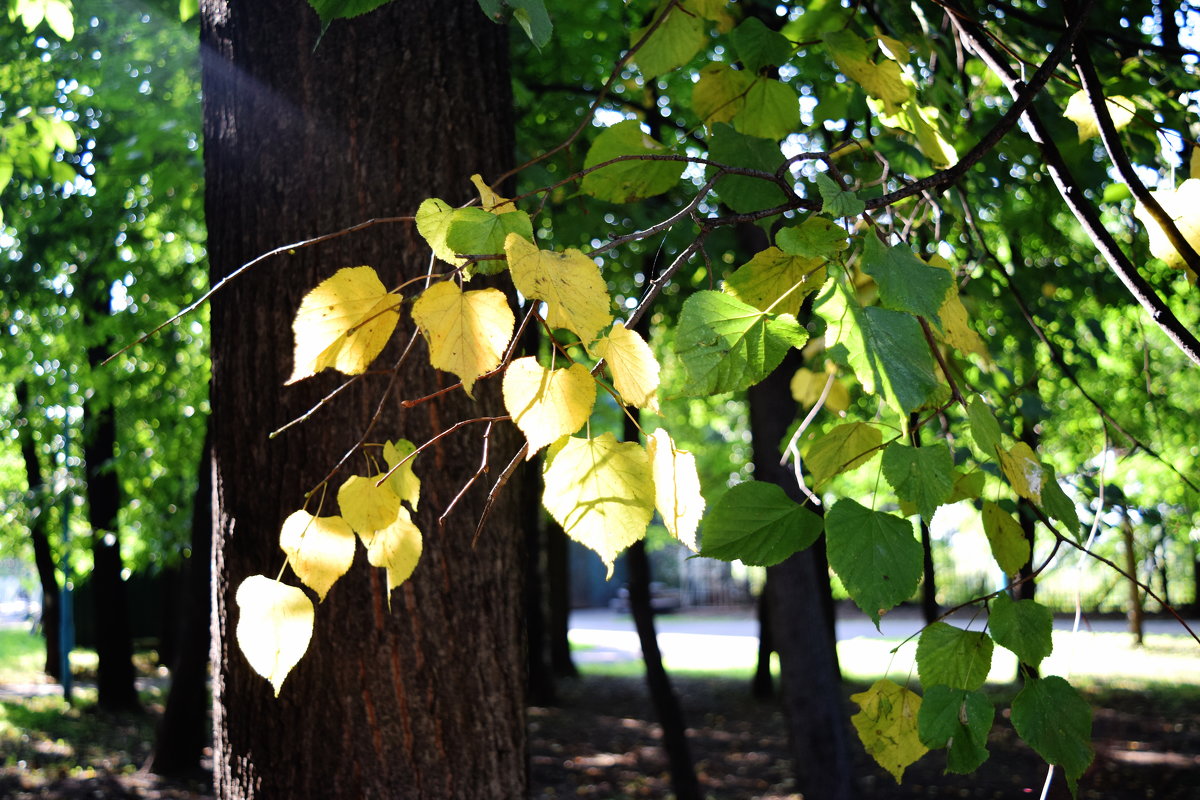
[917,686,996,775]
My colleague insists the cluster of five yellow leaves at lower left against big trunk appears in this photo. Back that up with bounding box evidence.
[235,439,421,697]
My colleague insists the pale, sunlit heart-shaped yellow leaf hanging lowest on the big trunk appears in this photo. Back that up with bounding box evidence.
[234,575,314,697]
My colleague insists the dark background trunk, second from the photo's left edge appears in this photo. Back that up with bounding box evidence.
[83,321,142,711]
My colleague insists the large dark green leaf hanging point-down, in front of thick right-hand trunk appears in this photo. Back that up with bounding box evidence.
[826,498,922,627]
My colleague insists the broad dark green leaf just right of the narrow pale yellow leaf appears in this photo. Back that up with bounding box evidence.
[700,481,824,566]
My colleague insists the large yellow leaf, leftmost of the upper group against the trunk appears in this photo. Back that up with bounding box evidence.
[287,266,401,384]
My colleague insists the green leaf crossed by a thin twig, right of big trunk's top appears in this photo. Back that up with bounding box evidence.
[581,120,686,203]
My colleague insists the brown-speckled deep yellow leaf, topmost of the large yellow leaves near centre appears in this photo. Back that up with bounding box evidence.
[504,234,612,344]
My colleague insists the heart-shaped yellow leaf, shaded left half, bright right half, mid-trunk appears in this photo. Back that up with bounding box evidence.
[413,280,513,397]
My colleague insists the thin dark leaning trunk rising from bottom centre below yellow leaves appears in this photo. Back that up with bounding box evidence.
[625,537,703,800]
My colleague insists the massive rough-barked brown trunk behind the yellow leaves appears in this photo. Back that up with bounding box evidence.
[202,0,526,800]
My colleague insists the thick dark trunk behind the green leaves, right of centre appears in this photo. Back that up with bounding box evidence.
[749,351,853,800]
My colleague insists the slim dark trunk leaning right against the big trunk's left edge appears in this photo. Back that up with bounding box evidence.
[148,434,212,777]
